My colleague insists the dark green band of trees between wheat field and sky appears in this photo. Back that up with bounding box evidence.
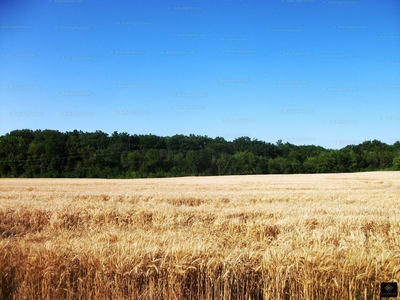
[0,129,400,178]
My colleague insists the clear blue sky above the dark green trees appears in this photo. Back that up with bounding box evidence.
[0,0,400,149]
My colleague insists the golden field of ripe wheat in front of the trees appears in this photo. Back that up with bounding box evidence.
[0,172,400,300]
